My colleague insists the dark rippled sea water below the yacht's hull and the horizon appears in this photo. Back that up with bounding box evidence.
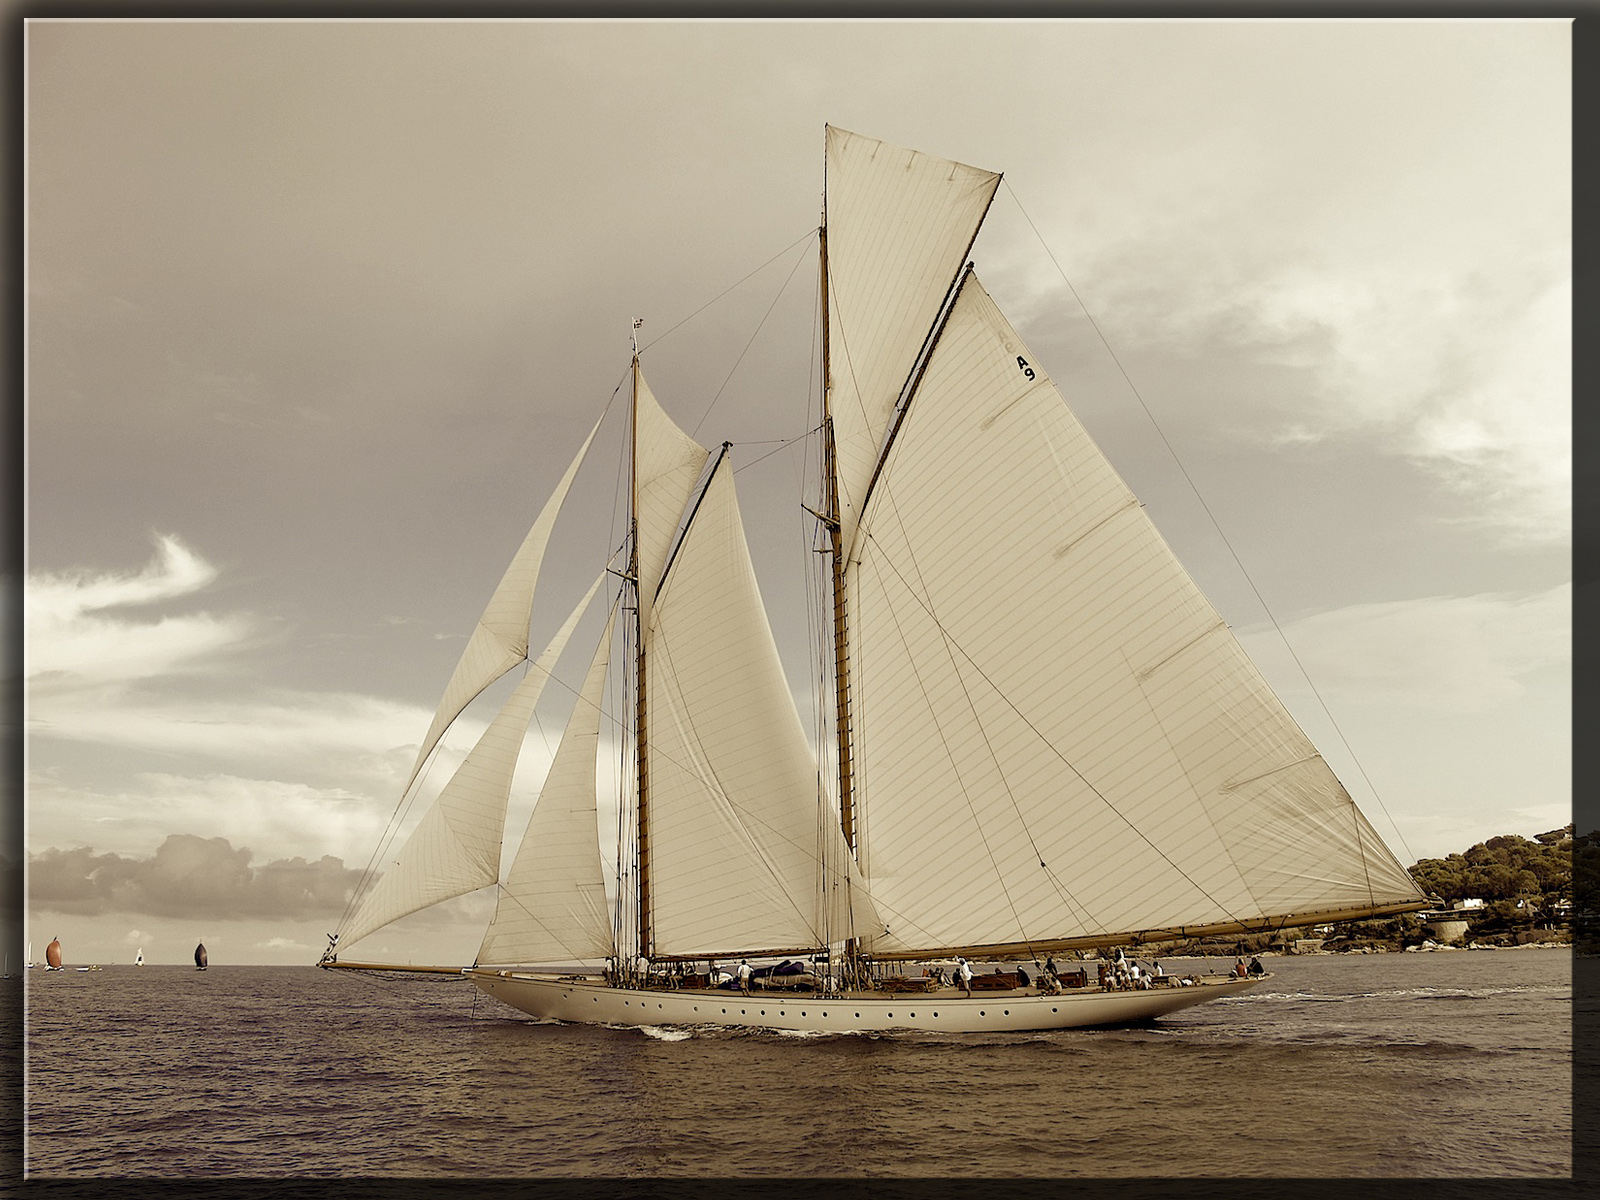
[18,949,1587,1179]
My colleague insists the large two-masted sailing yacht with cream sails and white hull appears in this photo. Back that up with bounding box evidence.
[320,126,1427,1032]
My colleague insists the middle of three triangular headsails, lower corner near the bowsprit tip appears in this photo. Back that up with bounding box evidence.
[339,576,605,947]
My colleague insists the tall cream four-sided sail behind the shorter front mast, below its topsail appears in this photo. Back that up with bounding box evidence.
[646,458,872,955]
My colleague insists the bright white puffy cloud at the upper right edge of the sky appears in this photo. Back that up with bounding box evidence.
[1242,264,1571,542]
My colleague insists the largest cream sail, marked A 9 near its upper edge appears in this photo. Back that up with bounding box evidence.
[850,277,1419,954]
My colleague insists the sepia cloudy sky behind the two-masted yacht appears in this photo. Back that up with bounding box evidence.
[18,19,1571,965]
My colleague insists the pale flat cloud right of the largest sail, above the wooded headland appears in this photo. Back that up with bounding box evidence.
[1240,584,1573,714]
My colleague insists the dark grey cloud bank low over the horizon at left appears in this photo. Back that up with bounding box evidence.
[29,834,360,918]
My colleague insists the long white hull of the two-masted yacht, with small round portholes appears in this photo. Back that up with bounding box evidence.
[466,970,1267,1034]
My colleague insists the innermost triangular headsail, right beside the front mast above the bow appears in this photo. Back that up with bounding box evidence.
[478,606,616,965]
